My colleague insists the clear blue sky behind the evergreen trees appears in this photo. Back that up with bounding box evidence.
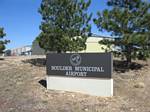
[0,0,108,49]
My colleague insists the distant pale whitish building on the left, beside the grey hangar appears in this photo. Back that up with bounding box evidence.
[11,45,31,56]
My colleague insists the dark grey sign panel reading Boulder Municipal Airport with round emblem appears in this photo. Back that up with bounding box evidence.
[46,53,112,78]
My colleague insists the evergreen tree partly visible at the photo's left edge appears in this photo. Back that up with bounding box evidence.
[0,28,9,53]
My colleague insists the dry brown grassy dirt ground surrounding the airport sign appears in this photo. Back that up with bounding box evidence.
[0,56,150,112]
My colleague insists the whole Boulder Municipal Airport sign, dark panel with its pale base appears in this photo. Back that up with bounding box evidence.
[46,53,113,96]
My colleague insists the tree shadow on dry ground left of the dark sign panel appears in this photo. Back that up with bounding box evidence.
[23,58,46,67]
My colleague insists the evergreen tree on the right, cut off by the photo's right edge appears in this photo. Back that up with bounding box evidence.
[94,0,150,65]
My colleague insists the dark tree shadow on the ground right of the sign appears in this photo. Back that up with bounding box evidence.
[113,60,146,73]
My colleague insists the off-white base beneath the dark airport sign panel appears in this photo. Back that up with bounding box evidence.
[47,76,113,97]
